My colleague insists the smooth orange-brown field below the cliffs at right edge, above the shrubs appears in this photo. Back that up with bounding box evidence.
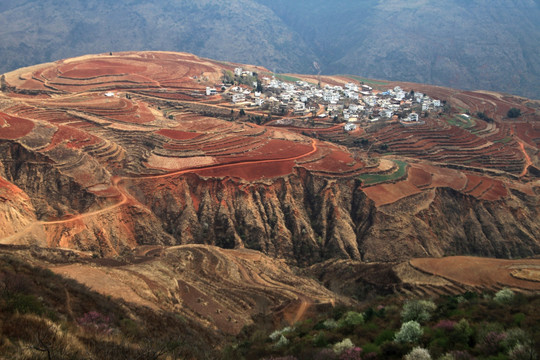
[410,256,540,291]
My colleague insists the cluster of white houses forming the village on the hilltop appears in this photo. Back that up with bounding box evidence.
[206,68,442,131]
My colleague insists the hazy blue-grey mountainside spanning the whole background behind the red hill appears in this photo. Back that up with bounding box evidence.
[0,0,540,98]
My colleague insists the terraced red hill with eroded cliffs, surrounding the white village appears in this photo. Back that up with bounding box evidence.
[0,52,540,265]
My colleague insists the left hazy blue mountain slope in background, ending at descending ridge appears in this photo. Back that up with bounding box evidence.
[0,0,311,75]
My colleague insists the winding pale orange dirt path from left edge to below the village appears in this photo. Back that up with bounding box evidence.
[0,139,318,244]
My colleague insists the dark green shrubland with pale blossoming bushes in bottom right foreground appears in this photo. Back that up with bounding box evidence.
[223,289,540,360]
